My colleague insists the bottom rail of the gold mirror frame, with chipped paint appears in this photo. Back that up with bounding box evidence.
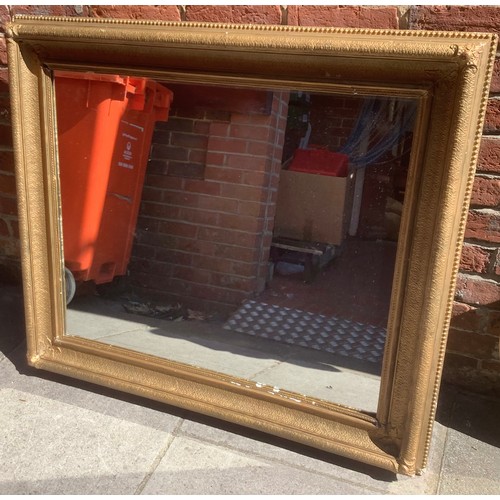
[28,337,404,475]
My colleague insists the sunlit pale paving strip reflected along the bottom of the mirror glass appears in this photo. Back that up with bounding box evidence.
[66,296,380,412]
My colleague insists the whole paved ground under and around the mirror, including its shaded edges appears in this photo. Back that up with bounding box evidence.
[0,287,500,495]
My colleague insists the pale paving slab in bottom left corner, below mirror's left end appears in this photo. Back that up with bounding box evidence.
[0,344,185,494]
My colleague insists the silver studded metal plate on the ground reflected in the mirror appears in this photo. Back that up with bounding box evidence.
[224,300,386,363]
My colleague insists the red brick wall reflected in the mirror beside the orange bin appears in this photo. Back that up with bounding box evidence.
[131,89,288,308]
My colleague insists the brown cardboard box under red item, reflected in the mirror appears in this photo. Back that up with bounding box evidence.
[274,170,354,245]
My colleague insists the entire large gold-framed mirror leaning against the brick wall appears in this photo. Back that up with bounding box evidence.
[6,16,496,475]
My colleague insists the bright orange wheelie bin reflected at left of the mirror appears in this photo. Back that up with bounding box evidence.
[55,71,173,296]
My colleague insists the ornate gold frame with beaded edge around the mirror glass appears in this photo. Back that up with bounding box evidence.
[6,16,496,475]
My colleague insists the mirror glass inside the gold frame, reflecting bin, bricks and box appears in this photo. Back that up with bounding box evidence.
[54,71,416,412]
